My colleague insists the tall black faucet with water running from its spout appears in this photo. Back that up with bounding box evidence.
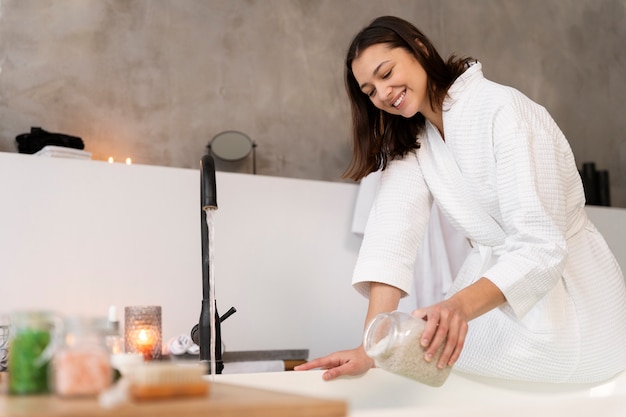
[191,155,237,374]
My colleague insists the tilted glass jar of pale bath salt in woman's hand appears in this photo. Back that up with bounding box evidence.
[363,311,451,387]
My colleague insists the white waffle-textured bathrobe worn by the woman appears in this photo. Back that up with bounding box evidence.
[353,63,626,382]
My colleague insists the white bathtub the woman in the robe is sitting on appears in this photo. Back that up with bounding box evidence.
[214,369,626,417]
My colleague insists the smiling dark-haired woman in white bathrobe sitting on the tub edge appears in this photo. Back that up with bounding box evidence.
[297,17,626,382]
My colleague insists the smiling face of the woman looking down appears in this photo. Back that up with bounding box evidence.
[352,44,432,118]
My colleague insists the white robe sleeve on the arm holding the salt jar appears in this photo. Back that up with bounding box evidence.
[483,93,572,317]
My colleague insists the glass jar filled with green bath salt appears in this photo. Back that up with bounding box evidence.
[8,311,57,395]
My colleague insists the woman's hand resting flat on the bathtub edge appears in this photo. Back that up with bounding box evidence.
[294,346,374,381]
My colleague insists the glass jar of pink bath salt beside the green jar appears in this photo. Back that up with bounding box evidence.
[51,317,113,397]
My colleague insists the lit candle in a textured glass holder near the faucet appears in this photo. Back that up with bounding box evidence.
[124,306,161,360]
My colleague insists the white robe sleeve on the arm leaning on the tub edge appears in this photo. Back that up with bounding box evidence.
[352,152,432,297]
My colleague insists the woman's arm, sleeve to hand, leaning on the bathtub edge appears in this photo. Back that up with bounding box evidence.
[295,152,432,380]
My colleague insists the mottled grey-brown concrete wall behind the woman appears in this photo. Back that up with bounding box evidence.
[0,0,626,207]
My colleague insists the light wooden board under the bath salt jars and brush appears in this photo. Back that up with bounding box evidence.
[0,383,348,417]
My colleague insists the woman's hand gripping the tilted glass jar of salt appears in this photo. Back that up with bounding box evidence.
[412,299,468,369]
